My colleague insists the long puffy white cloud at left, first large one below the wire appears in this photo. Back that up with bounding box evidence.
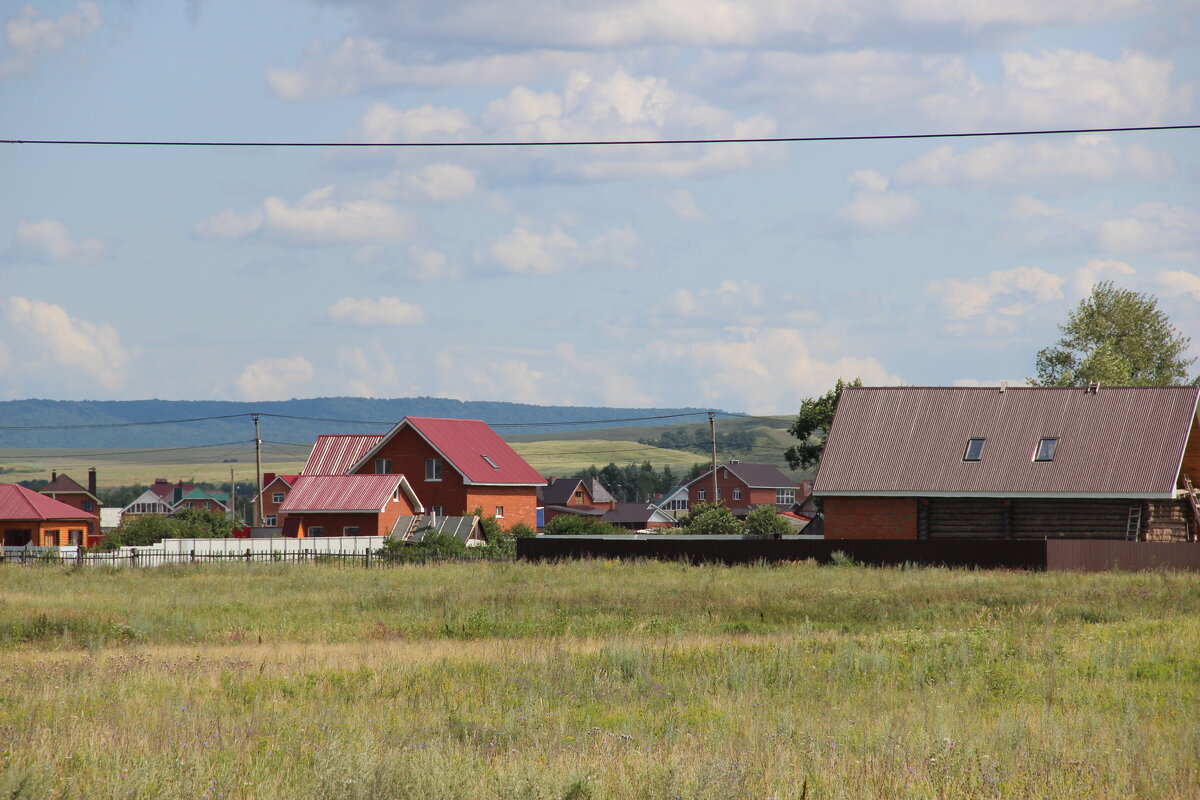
[194,186,414,245]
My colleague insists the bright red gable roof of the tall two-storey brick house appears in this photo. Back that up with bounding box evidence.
[347,416,546,486]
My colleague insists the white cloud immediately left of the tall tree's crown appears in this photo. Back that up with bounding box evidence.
[926,266,1066,333]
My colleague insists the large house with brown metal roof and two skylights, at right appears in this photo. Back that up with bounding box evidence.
[814,385,1200,541]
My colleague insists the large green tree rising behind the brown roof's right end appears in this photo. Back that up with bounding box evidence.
[1028,281,1195,386]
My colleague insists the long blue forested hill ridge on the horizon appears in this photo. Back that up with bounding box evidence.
[0,397,708,449]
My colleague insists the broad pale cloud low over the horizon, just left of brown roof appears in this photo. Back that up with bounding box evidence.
[642,327,901,414]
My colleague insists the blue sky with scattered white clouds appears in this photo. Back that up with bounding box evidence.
[0,0,1200,414]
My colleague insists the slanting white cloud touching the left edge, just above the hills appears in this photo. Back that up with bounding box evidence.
[8,296,128,389]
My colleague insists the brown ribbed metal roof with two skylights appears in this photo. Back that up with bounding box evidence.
[812,386,1200,498]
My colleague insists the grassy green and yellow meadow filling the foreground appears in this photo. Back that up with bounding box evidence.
[0,561,1200,800]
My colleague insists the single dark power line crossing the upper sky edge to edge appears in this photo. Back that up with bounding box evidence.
[0,125,1200,148]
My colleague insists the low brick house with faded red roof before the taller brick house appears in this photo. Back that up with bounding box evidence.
[278,474,425,539]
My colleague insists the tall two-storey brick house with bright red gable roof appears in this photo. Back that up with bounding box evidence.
[345,416,546,528]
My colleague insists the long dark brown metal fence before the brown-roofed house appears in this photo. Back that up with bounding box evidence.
[517,536,1200,571]
